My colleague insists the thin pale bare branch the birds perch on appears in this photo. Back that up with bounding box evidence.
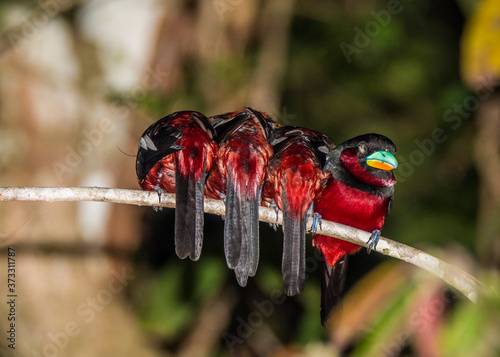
[0,187,481,301]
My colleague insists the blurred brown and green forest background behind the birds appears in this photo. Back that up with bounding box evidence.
[0,0,500,357]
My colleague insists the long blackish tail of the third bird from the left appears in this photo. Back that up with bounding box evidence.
[281,190,306,296]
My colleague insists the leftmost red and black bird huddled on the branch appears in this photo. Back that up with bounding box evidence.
[136,111,218,260]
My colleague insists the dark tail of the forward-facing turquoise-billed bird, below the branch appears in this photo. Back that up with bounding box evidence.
[320,254,349,326]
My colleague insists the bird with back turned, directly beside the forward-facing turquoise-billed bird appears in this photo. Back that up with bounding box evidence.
[263,126,334,296]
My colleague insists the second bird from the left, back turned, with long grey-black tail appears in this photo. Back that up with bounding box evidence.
[205,108,277,286]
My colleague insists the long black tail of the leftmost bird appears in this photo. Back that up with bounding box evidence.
[175,163,206,261]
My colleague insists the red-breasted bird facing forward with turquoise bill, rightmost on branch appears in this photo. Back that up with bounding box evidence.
[313,134,398,324]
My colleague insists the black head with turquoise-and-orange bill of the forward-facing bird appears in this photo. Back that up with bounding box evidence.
[326,134,398,187]
